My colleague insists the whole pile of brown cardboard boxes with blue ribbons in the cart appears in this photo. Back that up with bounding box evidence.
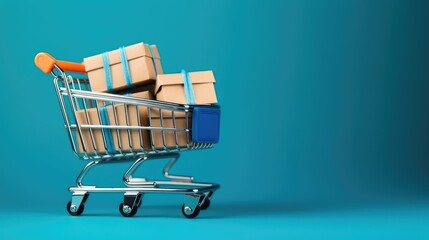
[76,43,217,153]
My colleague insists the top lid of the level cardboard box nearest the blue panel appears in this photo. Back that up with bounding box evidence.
[155,70,215,94]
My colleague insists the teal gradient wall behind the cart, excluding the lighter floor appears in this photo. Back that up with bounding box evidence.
[0,1,429,205]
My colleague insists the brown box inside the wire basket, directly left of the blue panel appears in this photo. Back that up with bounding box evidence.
[150,109,192,149]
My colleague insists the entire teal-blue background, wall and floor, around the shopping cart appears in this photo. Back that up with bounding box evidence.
[0,0,429,239]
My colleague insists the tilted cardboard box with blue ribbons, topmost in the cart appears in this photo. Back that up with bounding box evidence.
[83,43,162,92]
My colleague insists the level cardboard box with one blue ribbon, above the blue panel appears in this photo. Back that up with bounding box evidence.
[155,71,217,104]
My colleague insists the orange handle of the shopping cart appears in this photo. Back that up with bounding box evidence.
[34,52,86,73]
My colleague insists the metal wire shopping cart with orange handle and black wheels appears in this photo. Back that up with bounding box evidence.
[35,53,220,218]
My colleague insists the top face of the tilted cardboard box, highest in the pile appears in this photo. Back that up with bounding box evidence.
[83,42,152,72]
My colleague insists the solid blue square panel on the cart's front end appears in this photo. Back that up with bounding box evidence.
[192,106,220,143]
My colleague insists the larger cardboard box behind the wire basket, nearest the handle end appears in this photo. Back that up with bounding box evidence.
[76,92,151,154]
